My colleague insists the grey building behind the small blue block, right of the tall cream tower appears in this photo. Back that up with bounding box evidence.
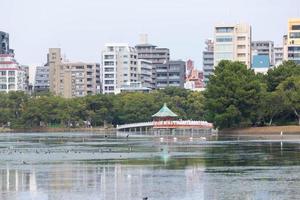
[251,41,275,66]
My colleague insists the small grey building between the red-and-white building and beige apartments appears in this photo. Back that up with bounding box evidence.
[34,65,50,92]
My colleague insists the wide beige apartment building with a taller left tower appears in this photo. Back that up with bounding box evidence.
[48,48,101,98]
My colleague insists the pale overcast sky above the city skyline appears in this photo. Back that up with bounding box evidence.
[0,0,300,68]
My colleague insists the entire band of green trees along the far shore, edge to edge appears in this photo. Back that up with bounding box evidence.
[0,61,300,129]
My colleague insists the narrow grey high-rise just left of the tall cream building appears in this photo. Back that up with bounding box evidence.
[202,39,214,85]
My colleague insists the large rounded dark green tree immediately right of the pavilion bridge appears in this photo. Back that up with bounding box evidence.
[204,61,265,129]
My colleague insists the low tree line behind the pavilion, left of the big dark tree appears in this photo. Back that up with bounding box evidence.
[0,87,204,128]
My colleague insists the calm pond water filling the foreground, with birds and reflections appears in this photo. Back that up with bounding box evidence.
[0,133,300,200]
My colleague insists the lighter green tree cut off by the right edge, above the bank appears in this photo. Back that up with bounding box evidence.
[277,76,300,125]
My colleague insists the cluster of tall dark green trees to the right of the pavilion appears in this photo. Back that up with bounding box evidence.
[204,61,300,129]
